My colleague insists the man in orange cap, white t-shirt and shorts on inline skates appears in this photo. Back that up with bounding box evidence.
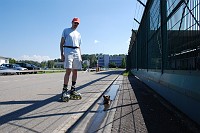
[60,18,82,101]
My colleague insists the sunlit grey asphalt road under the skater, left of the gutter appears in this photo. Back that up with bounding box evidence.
[0,70,123,133]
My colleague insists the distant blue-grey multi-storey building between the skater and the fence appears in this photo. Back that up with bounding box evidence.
[98,54,125,67]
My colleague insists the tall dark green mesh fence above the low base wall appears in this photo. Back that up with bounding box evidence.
[127,0,200,72]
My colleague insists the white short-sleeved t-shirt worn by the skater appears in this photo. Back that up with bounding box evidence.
[62,28,81,47]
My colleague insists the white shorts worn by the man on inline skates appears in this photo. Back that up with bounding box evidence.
[64,48,82,69]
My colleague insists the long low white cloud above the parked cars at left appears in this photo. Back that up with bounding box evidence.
[19,55,53,62]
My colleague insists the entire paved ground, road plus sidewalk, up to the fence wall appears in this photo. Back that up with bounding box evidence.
[0,70,200,133]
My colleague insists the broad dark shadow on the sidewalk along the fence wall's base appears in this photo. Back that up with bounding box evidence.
[128,76,200,133]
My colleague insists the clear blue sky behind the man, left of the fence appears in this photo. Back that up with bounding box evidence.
[0,0,146,62]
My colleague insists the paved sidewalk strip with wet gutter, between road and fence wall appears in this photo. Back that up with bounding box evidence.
[68,75,200,133]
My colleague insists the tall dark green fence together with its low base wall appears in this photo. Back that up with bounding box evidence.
[127,0,200,125]
